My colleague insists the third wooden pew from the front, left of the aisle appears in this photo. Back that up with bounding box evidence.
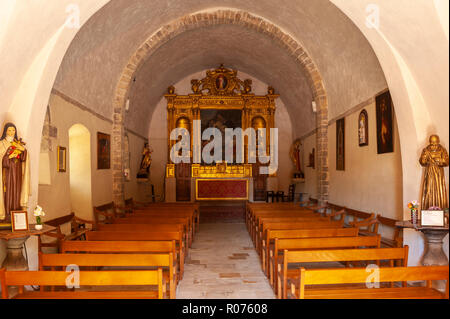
[61,240,181,281]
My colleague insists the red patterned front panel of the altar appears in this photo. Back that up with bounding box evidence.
[196,179,248,200]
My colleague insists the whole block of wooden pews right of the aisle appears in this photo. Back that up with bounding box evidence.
[245,202,449,299]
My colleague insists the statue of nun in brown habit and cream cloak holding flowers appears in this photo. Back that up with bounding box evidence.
[0,123,30,223]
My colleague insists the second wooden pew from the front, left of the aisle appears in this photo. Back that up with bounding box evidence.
[39,253,176,299]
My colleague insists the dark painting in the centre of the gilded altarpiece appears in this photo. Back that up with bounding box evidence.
[200,109,242,165]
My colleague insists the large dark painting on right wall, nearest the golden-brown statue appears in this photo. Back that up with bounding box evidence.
[375,91,394,154]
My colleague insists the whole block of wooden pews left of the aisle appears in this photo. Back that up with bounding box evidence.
[0,200,199,299]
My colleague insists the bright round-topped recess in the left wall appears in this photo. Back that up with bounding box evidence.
[68,124,93,220]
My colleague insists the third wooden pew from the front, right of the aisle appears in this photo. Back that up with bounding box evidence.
[269,235,380,293]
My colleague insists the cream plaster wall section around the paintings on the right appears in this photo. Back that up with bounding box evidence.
[328,103,403,220]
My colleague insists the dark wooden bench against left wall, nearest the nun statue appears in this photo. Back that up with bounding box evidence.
[38,212,95,252]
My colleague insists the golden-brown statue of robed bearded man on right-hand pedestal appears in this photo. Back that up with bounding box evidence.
[419,135,449,210]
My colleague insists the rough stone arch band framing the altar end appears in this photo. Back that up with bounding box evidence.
[112,9,329,208]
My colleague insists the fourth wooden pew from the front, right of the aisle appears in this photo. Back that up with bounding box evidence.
[262,228,358,277]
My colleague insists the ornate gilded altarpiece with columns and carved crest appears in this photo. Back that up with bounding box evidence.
[165,65,279,201]
